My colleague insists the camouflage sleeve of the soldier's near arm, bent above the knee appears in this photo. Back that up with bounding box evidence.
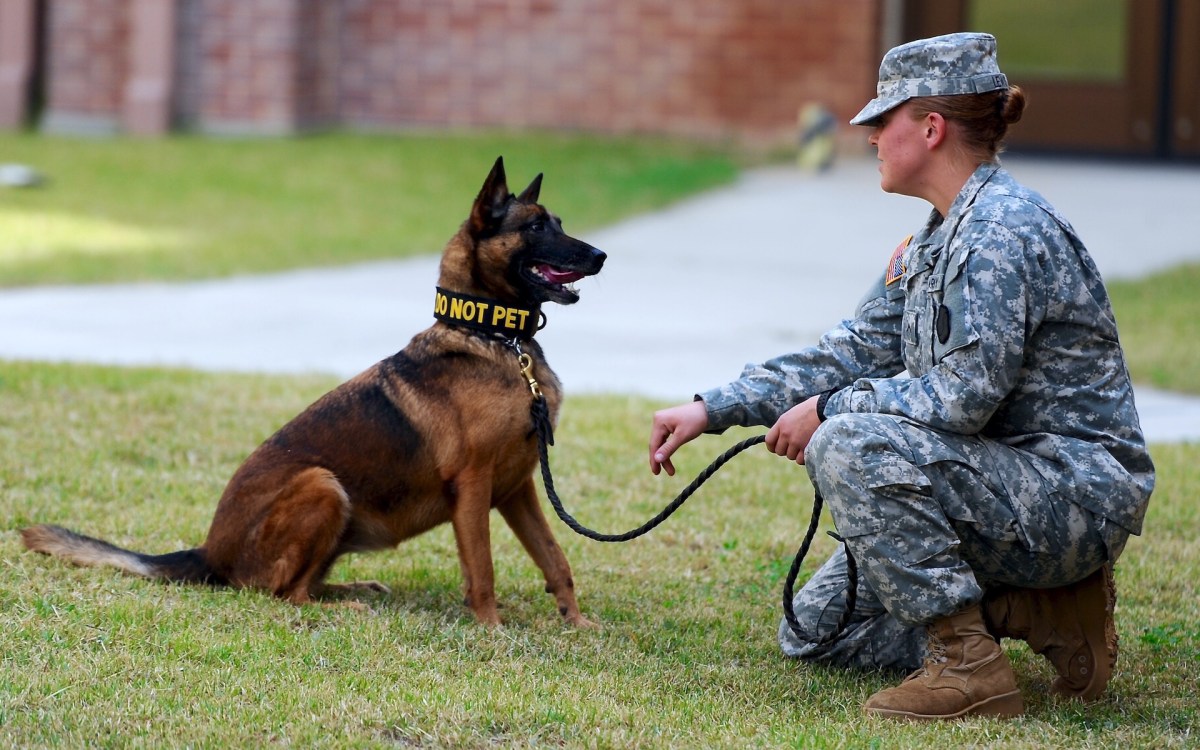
[826,221,1045,434]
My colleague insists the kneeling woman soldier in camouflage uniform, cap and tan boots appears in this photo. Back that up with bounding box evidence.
[649,34,1154,719]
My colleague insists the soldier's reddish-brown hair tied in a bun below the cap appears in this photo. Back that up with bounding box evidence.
[910,85,1026,163]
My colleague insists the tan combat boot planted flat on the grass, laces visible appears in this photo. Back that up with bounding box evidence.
[864,605,1024,719]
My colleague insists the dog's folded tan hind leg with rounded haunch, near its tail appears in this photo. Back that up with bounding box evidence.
[246,467,350,605]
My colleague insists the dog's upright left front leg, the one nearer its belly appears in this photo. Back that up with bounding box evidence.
[450,468,500,625]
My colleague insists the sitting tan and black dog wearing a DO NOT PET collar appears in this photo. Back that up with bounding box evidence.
[22,158,605,626]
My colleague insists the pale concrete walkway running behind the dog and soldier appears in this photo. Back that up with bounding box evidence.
[0,157,1200,442]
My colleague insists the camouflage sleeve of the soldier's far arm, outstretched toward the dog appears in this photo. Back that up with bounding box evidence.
[698,276,904,432]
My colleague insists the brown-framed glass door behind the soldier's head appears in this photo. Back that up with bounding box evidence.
[905,0,1185,156]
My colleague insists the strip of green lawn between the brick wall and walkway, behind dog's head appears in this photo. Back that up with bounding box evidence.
[0,133,736,287]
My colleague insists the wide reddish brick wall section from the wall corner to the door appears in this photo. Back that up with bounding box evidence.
[340,0,878,145]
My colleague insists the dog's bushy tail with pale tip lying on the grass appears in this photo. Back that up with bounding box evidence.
[20,526,223,583]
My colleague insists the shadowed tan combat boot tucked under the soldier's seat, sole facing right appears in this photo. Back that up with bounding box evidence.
[983,565,1117,701]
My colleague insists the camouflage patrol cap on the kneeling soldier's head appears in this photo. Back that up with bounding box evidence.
[850,32,1008,125]
